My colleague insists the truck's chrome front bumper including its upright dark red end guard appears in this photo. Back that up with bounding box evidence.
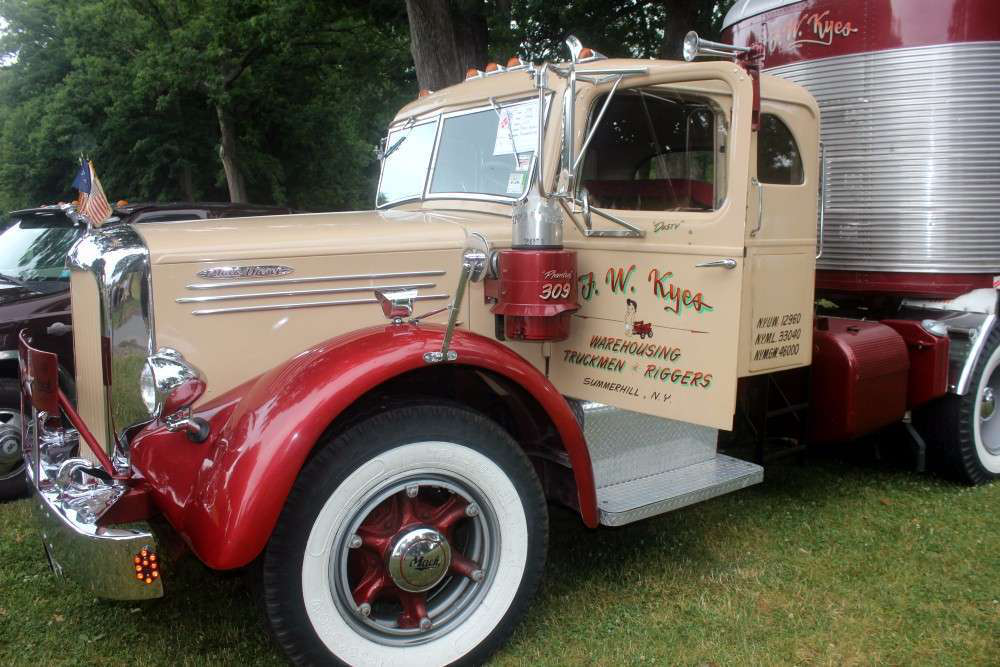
[20,332,163,600]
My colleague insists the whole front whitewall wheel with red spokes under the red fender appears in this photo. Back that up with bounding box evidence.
[263,405,548,665]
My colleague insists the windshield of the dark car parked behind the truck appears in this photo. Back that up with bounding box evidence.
[0,216,80,287]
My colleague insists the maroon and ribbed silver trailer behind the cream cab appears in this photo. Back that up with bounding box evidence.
[724,0,1000,288]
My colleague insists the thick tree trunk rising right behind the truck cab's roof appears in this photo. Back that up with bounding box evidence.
[406,0,488,90]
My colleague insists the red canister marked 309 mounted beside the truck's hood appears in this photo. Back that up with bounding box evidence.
[487,250,579,341]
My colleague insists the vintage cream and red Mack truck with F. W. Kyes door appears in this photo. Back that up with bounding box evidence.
[11,20,998,665]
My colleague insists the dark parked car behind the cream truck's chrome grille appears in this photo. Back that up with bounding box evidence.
[0,202,295,500]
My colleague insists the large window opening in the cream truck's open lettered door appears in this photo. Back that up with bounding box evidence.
[580,88,725,211]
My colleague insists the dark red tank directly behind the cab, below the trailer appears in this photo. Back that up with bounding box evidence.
[810,317,910,442]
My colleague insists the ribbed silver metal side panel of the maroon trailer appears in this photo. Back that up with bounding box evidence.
[767,42,1000,273]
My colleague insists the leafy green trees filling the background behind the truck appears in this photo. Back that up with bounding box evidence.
[0,0,732,211]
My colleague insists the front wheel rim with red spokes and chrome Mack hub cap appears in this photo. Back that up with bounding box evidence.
[329,473,500,646]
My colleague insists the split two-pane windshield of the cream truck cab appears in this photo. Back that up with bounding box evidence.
[376,99,538,206]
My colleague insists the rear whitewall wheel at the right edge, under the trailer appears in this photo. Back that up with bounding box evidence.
[924,329,1000,484]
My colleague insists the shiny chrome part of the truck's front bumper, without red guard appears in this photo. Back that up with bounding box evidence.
[22,414,163,600]
